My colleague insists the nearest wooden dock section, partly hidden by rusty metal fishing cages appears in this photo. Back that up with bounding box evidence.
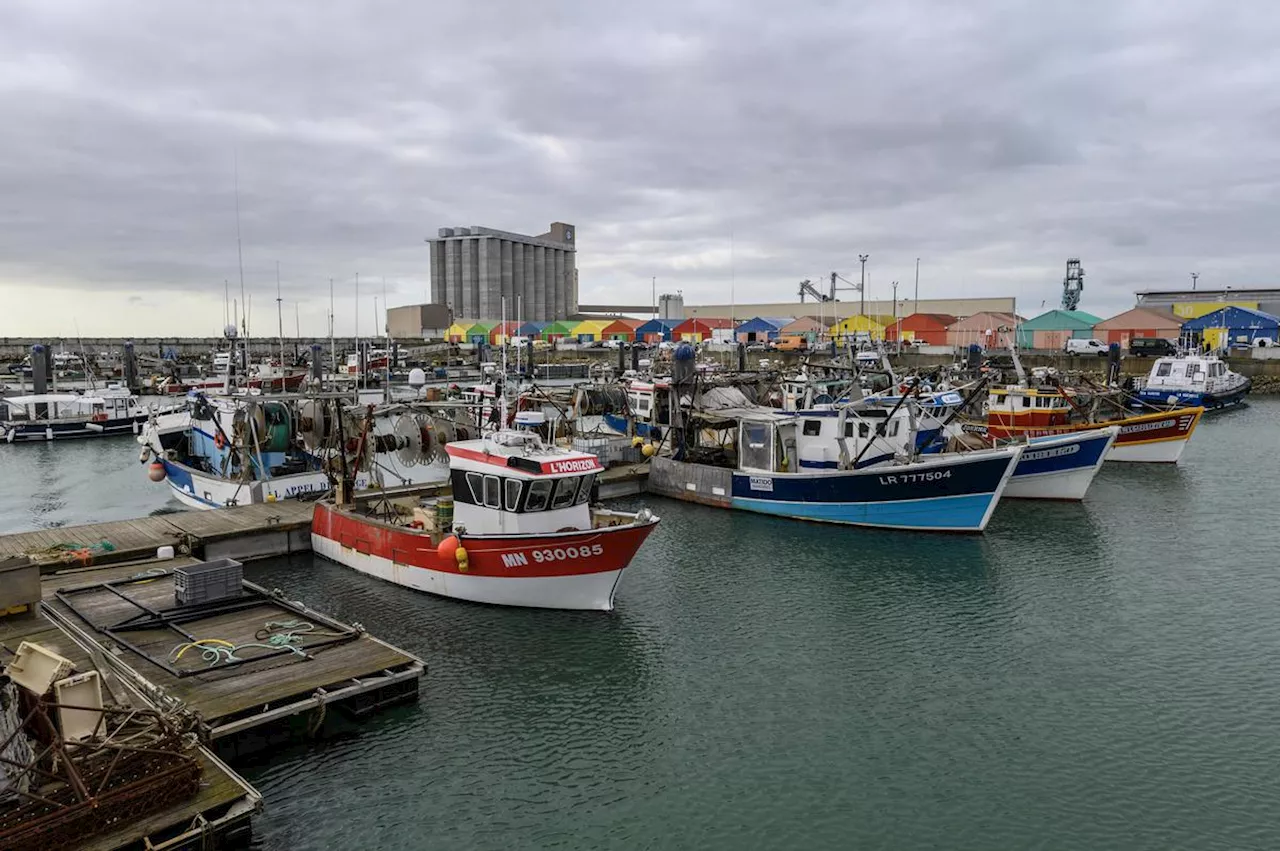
[0,617,262,851]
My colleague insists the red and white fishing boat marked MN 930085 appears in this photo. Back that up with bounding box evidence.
[311,411,658,610]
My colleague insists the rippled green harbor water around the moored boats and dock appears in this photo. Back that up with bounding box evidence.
[0,398,1280,851]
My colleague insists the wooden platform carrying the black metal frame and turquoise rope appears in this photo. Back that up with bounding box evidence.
[42,555,425,741]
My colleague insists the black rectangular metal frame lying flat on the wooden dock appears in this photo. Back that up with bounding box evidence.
[54,571,362,678]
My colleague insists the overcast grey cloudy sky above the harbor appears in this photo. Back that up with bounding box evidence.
[0,0,1280,335]
